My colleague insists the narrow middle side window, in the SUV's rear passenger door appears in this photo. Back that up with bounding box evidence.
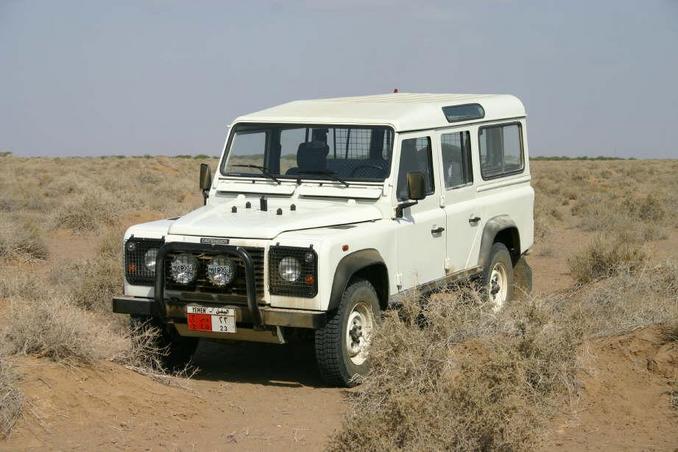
[440,132,473,188]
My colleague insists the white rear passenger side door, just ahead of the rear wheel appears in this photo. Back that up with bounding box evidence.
[437,129,481,275]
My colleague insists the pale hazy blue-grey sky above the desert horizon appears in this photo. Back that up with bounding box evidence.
[0,0,678,158]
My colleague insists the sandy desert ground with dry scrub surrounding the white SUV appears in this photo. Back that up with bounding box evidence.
[0,155,678,451]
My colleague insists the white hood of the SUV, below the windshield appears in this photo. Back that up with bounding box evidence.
[168,200,382,239]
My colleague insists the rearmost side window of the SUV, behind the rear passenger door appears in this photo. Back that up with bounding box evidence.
[478,124,524,179]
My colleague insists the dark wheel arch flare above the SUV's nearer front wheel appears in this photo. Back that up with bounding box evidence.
[327,248,389,311]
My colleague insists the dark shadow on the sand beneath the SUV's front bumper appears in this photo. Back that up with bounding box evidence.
[187,340,326,387]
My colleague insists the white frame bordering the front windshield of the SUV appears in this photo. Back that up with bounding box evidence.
[219,121,398,186]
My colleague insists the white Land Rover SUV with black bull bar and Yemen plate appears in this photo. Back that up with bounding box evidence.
[113,93,534,385]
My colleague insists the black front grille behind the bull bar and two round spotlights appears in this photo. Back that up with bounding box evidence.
[164,247,264,299]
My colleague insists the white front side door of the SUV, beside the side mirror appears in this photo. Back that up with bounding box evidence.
[395,135,446,291]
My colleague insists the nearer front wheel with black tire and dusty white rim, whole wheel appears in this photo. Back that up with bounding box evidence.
[315,280,381,386]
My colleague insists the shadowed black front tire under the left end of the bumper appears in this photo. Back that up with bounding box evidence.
[130,316,199,372]
